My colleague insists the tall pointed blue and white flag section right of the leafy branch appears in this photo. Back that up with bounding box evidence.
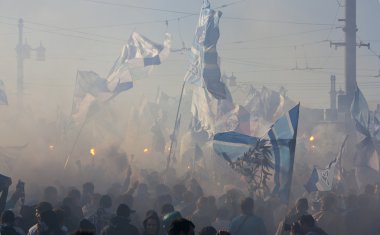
[268,104,300,202]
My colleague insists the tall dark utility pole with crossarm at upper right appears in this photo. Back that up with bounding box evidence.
[330,0,370,113]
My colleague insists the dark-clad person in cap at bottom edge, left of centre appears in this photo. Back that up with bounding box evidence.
[101,204,140,235]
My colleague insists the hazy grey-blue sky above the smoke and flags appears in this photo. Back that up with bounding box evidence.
[0,0,380,114]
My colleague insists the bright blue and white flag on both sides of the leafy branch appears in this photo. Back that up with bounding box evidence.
[213,104,299,202]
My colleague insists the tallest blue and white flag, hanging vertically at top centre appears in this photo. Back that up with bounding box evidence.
[185,0,226,99]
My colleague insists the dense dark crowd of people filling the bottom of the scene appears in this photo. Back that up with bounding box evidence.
[0,165,380,235]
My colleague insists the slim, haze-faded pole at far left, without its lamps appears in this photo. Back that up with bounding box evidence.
[16,18,24,106]
